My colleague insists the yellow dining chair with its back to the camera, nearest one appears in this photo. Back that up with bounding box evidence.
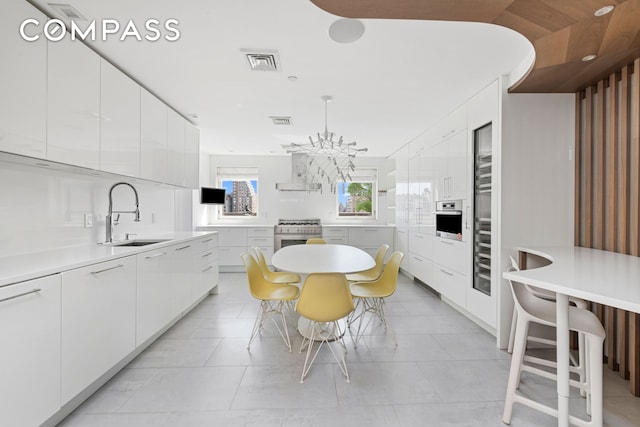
[296,273,354,383]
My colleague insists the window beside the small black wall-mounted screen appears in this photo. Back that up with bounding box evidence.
[218,167,258,217]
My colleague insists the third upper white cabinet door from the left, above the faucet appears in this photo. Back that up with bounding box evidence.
[100,59,140,177]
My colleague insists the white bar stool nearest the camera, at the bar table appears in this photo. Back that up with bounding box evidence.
[502,281,605,427]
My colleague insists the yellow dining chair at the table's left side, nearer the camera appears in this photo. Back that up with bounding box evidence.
[240,252,300,351]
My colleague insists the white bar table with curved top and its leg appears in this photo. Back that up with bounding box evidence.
[503,246,640,427]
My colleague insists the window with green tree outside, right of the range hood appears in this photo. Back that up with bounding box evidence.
[337,169,378,218]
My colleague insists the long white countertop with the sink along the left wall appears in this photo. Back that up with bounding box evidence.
[0,232,211,287]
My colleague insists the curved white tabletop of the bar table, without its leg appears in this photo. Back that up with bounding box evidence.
[504,246,640,313]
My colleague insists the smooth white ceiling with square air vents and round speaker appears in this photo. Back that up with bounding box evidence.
[27,0,533,156]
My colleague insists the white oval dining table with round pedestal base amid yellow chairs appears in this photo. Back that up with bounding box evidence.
[271,244,376,340]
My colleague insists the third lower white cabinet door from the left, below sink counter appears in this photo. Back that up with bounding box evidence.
[136,247,174,345]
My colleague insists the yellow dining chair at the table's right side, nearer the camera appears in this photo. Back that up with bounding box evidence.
[349,251,404,348]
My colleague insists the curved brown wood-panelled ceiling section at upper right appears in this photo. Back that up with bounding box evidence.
[311,0,640,93]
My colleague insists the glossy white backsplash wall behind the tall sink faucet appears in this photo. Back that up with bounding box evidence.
[0,160,193,256]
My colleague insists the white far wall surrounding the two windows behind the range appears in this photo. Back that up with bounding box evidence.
[201,155,387,225]
